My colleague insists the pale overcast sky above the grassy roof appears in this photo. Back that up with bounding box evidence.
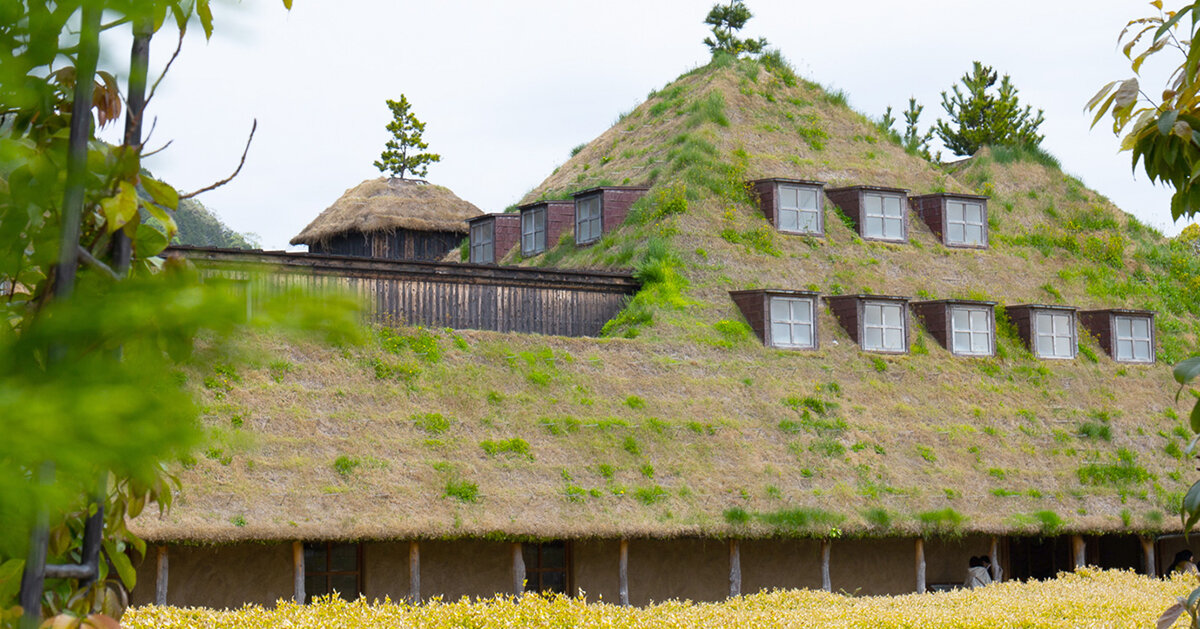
[103,0,1183,248]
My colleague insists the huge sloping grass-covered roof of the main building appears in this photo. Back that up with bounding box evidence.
[134,59,1200,541]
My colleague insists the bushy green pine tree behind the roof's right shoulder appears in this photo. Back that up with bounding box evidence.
[935,61,1043,155]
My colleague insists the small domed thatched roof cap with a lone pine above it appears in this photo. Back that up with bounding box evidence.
[292,176,484,245]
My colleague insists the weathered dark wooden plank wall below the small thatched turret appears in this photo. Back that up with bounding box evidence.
[166,246,640,336]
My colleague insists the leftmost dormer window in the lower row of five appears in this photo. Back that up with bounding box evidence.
[730,289,817,349]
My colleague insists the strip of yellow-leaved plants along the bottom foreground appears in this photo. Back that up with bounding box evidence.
[121,569,1196,629]
